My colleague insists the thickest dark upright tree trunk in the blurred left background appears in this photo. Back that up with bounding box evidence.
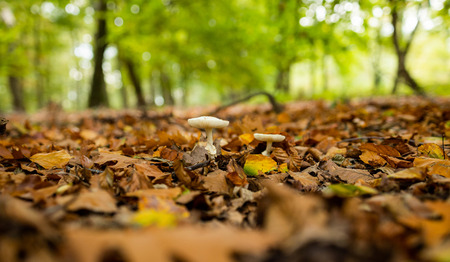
[89,0,109,107]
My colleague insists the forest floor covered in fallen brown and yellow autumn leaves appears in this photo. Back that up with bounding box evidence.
[0,97,450,262]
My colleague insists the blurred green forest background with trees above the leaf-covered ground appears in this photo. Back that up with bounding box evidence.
[0,0,450,112]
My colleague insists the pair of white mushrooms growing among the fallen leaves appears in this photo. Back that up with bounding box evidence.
[188,116,285,156]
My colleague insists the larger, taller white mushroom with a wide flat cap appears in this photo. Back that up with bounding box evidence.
[188,116,229,155]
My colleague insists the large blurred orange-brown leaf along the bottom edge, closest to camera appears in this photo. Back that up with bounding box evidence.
[65,227,274,262]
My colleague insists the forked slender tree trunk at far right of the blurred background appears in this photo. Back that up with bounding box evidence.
[391,3,425,95]
